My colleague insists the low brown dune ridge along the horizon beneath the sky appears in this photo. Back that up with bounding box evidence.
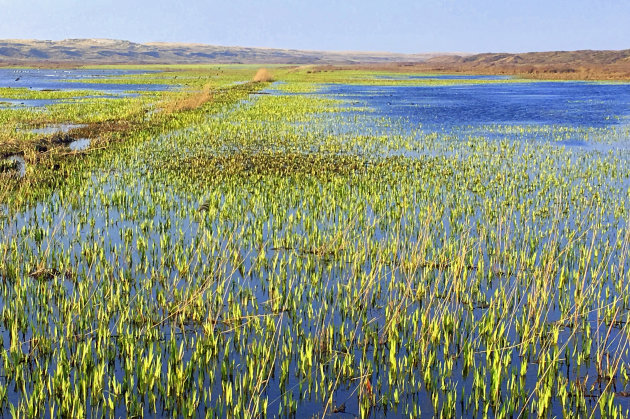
[0,39,630,80]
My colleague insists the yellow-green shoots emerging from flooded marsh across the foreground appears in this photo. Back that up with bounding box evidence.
[0,67,630,417]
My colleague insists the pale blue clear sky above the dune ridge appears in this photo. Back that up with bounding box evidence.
[0,0,630,53]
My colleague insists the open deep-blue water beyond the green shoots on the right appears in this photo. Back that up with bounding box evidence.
[322,79,630,140]
